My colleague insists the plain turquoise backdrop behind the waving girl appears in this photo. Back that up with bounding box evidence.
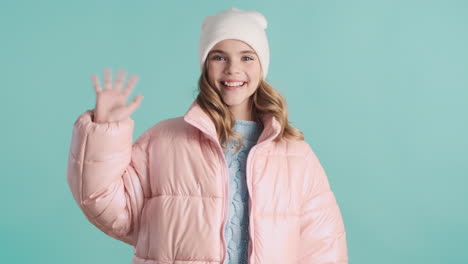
[0,0,468,264]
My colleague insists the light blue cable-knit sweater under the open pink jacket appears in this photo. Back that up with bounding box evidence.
[224,120,263,264]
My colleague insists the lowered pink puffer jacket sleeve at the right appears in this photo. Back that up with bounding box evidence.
[298,146,348,264]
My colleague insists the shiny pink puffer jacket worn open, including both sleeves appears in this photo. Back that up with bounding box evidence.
[67,101,348,264]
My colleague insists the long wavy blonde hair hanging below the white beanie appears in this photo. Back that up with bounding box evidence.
[196,63,304,153]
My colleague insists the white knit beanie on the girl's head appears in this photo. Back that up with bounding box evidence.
[198,7,270,79]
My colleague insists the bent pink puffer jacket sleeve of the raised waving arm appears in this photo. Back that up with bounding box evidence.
[67,110,149,246]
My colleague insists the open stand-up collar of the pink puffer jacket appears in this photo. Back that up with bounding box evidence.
[184,100,281,144]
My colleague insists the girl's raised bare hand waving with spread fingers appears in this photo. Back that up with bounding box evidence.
[91,68,143,123]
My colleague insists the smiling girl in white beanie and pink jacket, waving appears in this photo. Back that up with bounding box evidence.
[67,8,348,264]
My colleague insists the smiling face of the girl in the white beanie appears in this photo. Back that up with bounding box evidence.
[206,39,262,111]
